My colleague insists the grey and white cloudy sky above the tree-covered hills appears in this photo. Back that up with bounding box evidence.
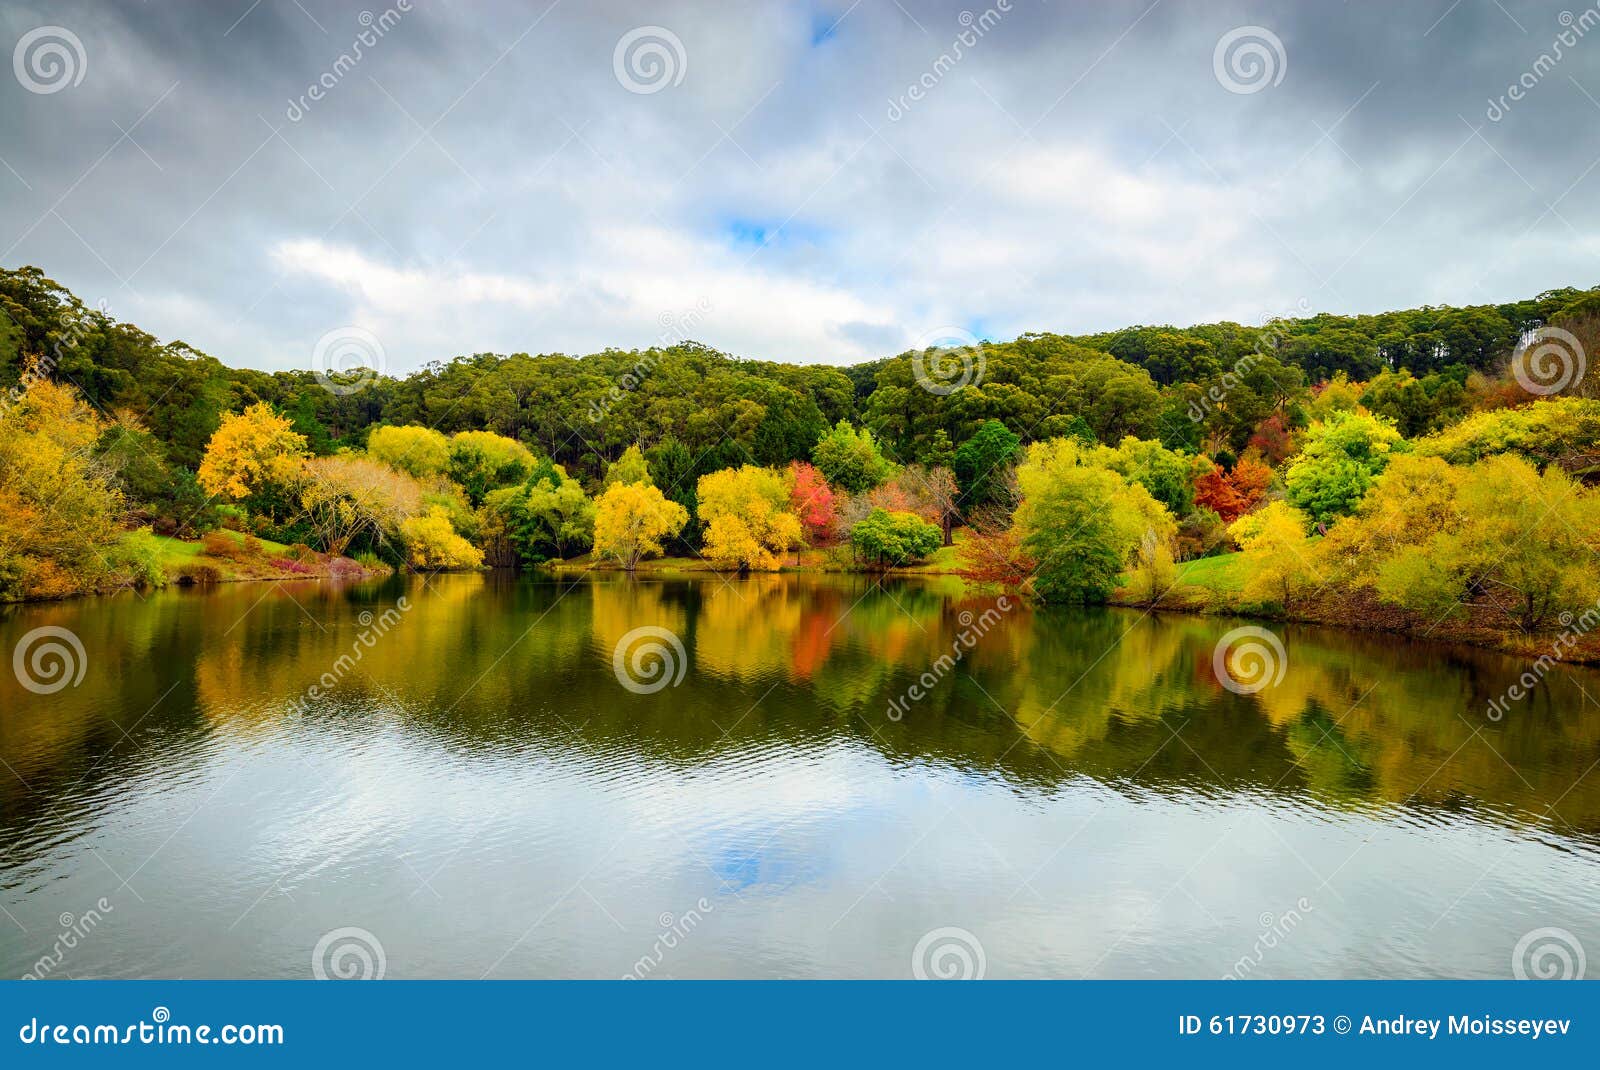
[0,0,1600,373]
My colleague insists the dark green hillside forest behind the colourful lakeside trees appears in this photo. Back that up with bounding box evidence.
[0,267,1600,480]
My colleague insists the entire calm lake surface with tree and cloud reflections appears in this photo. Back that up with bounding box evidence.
[0,574,1600,979]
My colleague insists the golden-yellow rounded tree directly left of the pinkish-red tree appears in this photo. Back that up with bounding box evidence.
[698,464,800,573]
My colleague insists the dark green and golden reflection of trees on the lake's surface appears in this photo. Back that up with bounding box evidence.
[9,576,1600,835]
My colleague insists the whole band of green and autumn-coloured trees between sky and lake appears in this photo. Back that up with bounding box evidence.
[0,267,1600,646]
